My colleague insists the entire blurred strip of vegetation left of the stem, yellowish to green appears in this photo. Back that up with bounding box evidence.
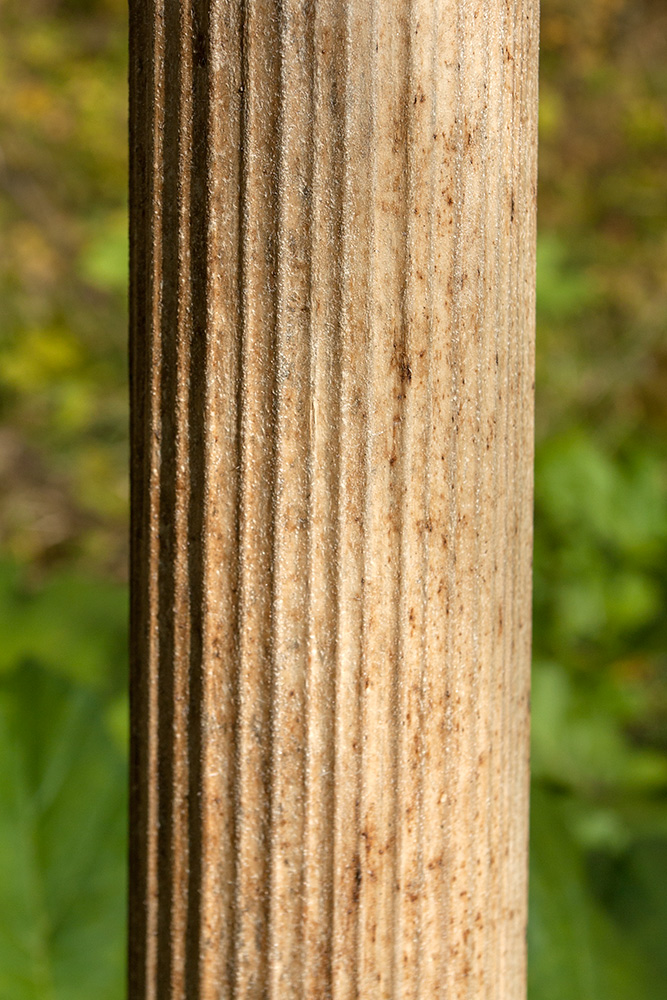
[0,0,128,1000]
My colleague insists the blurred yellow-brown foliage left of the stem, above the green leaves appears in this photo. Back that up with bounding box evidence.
[0,0,127,574]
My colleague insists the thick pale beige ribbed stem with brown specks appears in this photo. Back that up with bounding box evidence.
[130,0,538,1000]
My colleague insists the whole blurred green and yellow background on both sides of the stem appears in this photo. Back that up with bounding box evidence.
[0,0,667,1000]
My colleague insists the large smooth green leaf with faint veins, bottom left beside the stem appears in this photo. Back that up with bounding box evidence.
[0,665,126,1000]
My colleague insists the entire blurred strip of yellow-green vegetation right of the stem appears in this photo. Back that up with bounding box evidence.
[529,0,667,1000]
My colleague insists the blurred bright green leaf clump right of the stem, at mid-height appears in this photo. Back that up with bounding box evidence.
[535,428,667,665]
